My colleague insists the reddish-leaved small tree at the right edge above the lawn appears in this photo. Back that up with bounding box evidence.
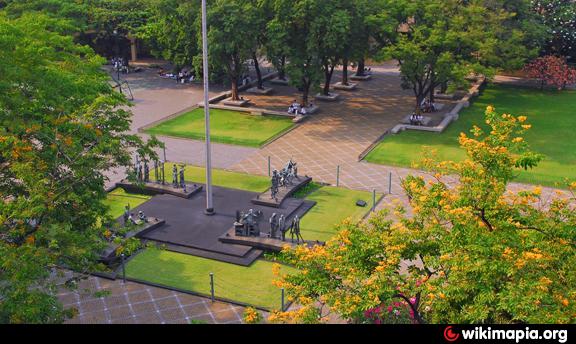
[524,55,576,90]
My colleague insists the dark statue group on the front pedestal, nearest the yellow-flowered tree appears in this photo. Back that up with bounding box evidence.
[234,209,304,243]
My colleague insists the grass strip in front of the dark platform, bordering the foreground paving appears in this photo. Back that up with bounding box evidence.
[126,249,296,309]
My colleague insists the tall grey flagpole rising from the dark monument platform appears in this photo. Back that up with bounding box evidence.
[202,0,214,215]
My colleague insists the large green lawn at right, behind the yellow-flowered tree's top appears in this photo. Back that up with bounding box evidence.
[366,85,576,186]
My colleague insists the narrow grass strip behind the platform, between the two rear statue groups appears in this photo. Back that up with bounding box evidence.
[174,162,270,192]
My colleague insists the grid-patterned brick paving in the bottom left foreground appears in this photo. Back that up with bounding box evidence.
[58,277,244,324]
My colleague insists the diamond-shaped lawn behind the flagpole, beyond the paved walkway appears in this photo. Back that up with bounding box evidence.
[146,108,294,147]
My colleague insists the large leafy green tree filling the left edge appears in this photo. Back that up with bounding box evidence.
[0,13,157,323]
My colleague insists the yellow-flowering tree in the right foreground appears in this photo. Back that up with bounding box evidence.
[276,107,576,323]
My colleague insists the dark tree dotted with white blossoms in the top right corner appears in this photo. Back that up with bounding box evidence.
[531,0,576,58]
